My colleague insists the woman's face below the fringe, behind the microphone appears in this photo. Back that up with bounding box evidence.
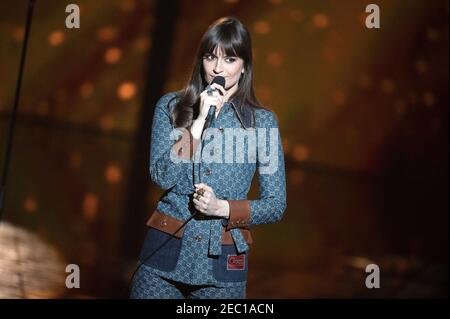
[203,47,244,90]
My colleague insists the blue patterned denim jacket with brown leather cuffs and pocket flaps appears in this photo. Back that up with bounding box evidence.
[140,92,286,286]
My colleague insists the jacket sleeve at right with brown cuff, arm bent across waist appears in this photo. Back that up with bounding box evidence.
[227,112,286,229]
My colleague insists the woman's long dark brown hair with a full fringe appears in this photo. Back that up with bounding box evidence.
[172,17,264,127]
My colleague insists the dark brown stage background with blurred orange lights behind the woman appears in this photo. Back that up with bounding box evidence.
[0,0,449,298]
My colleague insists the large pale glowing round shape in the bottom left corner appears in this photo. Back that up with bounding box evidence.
[0,221,67,298]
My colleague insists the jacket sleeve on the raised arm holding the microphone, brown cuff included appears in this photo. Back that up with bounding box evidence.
[150,94,199,190]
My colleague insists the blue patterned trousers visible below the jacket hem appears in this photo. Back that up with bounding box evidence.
[130,265,245,299]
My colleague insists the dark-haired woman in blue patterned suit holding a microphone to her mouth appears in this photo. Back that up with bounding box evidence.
[131,17,286,299]
